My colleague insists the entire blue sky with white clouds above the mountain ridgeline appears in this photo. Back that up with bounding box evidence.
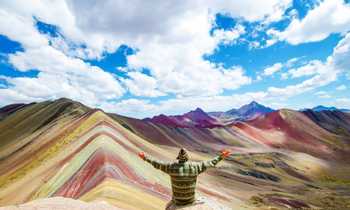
[0,0,350,118]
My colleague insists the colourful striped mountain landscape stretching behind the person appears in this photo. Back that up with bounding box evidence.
[0,98,350,210]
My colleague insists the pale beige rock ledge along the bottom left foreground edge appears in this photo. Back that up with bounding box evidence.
[0,197,122,210]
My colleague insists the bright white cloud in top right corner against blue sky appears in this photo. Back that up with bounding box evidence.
[270,0,350,45]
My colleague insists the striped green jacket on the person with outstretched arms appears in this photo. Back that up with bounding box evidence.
[145,156,223,205]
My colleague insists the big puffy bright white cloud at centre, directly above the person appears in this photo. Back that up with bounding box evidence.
[122,8,250,95]
